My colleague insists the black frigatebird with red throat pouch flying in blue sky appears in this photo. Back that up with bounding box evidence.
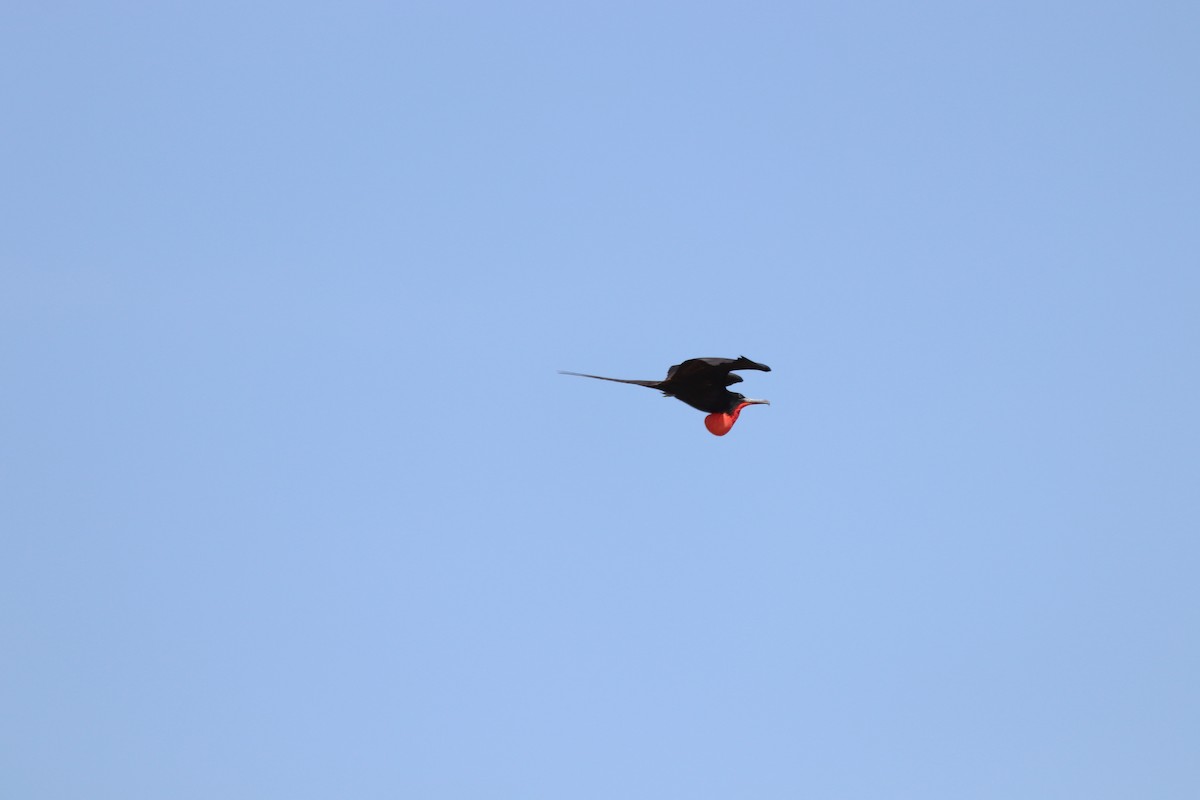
[559,355,770,437]
